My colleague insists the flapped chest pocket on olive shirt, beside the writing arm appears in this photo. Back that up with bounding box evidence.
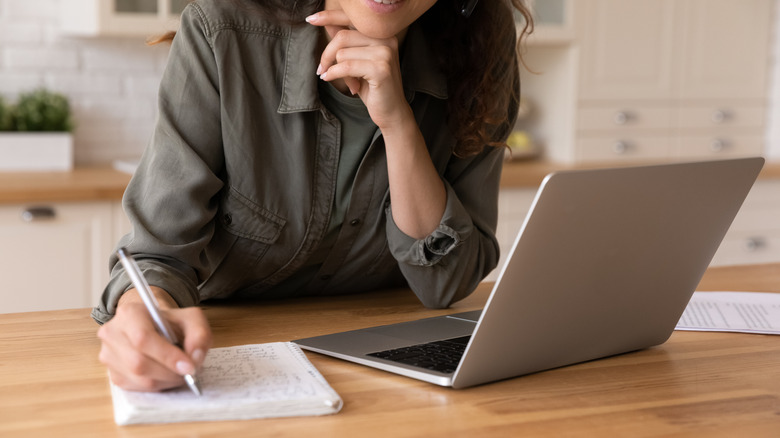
[200,189,286,299]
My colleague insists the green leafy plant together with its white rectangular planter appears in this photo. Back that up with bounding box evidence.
[0,88,73,171]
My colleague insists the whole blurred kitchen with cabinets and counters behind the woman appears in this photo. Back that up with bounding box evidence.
[0,0,780,312]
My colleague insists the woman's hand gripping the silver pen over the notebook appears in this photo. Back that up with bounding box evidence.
[98,287,211,391]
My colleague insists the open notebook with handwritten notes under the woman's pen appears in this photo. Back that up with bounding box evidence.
[111,342,343,425]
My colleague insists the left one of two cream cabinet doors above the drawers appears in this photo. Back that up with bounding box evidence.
[576,0,675,100]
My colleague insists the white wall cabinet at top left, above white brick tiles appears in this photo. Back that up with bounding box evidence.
[60,0,189,37]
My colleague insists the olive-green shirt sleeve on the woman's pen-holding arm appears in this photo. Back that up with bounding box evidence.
[92,5,224,323]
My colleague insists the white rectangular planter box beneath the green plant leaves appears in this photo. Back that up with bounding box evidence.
[0,132,73,171]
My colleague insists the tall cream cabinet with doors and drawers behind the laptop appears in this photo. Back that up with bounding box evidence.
[523,0,774,163]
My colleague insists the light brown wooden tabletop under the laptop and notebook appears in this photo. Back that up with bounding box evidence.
[0,265,780,438]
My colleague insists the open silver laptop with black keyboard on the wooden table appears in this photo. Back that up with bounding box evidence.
[294,158,764,388]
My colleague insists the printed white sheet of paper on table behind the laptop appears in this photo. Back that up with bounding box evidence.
[676,292,780,335]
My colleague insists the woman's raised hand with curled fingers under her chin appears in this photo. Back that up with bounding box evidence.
[306,10,413,132]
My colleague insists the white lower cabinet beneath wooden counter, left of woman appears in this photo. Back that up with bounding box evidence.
[0,202,113,313]
